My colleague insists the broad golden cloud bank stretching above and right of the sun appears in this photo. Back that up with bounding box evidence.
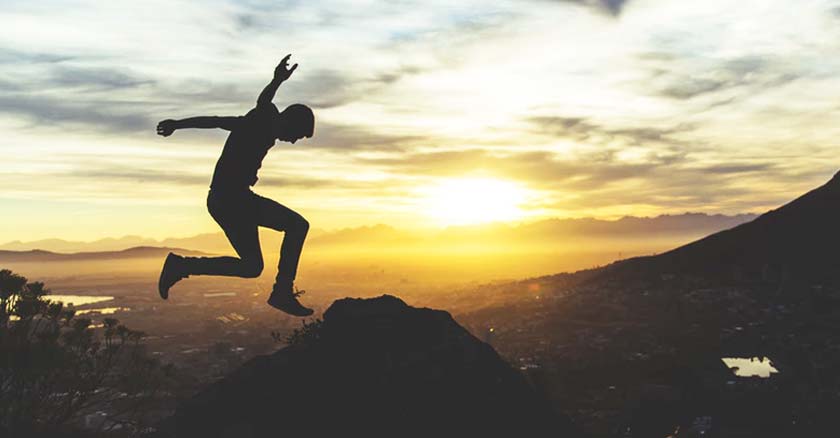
[359,145,803,215]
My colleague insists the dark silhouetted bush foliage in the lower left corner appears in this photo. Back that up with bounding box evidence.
[0,269,171,436]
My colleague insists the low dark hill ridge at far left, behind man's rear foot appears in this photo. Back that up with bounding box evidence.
[0,246,208,263]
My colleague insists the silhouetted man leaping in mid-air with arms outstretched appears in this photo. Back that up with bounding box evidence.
[157,55,315,316]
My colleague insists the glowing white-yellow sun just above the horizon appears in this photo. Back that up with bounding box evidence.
[422,178,526,225]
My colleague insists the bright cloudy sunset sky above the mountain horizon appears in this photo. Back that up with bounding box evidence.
[0,0,840,242]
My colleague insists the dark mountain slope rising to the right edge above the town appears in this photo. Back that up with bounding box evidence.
[604,168,840,284]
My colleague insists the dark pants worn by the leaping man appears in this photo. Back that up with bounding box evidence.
[184,190,309,282]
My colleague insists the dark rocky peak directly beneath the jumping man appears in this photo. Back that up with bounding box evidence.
[158,295,577,438]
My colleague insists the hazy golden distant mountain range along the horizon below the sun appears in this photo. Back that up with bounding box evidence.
[0,213,756,253]
